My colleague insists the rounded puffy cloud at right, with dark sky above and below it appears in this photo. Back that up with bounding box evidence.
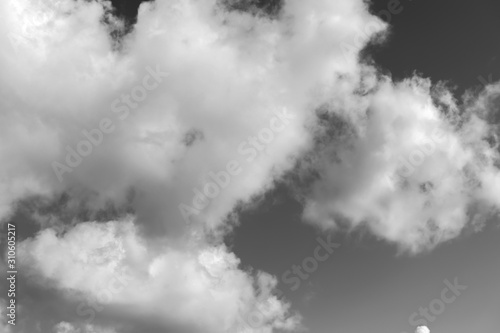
[296,77,500,252]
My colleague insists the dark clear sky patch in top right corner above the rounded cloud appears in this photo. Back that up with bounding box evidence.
[370,0,500,89]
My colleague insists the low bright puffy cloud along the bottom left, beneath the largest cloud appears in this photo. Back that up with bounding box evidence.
[19,220,299,332]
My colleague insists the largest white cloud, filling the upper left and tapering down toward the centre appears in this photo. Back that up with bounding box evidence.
[0,0,382,225]
